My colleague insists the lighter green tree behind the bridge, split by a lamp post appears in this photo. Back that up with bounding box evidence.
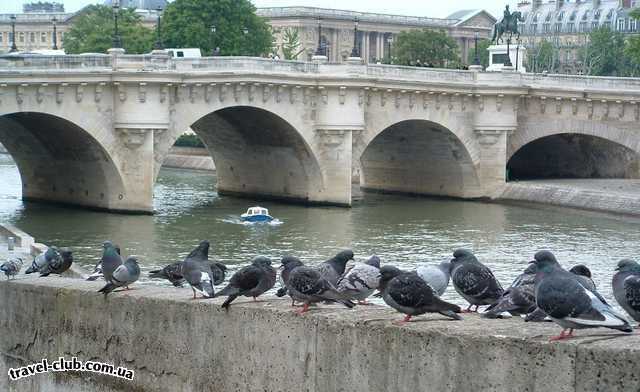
[64,5,154,54]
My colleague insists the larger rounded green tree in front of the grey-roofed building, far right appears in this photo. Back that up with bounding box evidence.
[578,27,628,76]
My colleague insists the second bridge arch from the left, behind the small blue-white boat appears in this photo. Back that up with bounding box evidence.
[165,104,324,202]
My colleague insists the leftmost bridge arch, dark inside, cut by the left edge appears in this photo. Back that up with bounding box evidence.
[0,111,126,210]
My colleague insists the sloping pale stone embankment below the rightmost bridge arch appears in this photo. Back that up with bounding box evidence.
[495,180,640,216]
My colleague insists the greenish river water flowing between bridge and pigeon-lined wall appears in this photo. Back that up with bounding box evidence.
[0,154,640,304]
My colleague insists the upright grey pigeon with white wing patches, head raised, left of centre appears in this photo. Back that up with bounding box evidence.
[180,240,214,299]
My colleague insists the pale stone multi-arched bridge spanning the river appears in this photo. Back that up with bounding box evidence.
[0,51,640,213]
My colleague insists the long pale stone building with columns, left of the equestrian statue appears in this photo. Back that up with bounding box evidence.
[258,7,496,63]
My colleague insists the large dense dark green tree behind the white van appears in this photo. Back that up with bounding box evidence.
[162,0,273,56]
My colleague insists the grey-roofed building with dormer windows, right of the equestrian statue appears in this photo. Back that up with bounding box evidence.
[517,0,640,74]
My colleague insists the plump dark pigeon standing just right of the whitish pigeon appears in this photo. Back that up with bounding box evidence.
[451,249,504,312]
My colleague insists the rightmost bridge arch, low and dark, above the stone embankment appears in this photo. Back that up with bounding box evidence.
[507,121,640,180]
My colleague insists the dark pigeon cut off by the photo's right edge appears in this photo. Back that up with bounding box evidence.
[611,260,640,322]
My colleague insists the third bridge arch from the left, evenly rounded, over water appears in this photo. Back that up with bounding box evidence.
[357,119,479,197]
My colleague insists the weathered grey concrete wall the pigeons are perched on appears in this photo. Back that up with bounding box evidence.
[0,278,640,392]
